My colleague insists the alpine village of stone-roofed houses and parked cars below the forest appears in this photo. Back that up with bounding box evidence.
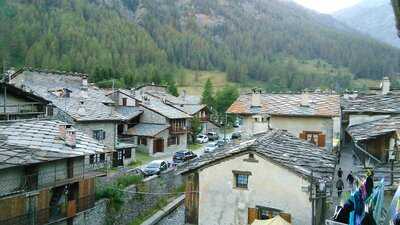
[0,68,400,225]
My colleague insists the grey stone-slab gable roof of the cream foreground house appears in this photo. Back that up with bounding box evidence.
[184,130,336,180]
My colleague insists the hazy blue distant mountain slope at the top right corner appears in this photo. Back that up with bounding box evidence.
[333,0,400,48]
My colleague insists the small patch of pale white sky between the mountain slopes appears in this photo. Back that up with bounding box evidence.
[294,0,361,13]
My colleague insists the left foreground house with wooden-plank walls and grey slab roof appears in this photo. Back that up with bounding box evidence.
[0,120,105,225]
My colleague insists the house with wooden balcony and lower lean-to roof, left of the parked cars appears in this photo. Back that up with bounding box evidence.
[108,88,191,154]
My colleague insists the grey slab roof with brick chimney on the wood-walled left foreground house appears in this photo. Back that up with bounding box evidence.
[0,120,105,168]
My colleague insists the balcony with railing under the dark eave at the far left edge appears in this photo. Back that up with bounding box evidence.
[0,103,46,114]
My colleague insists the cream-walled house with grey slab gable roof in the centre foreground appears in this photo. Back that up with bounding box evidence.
[182,130,336,225]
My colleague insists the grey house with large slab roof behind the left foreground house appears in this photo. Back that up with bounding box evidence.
[9,68,136,169]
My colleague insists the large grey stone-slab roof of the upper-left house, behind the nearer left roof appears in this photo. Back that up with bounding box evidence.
[10,69,126,121]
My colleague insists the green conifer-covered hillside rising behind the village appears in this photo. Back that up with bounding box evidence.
[0,0,400,90]
